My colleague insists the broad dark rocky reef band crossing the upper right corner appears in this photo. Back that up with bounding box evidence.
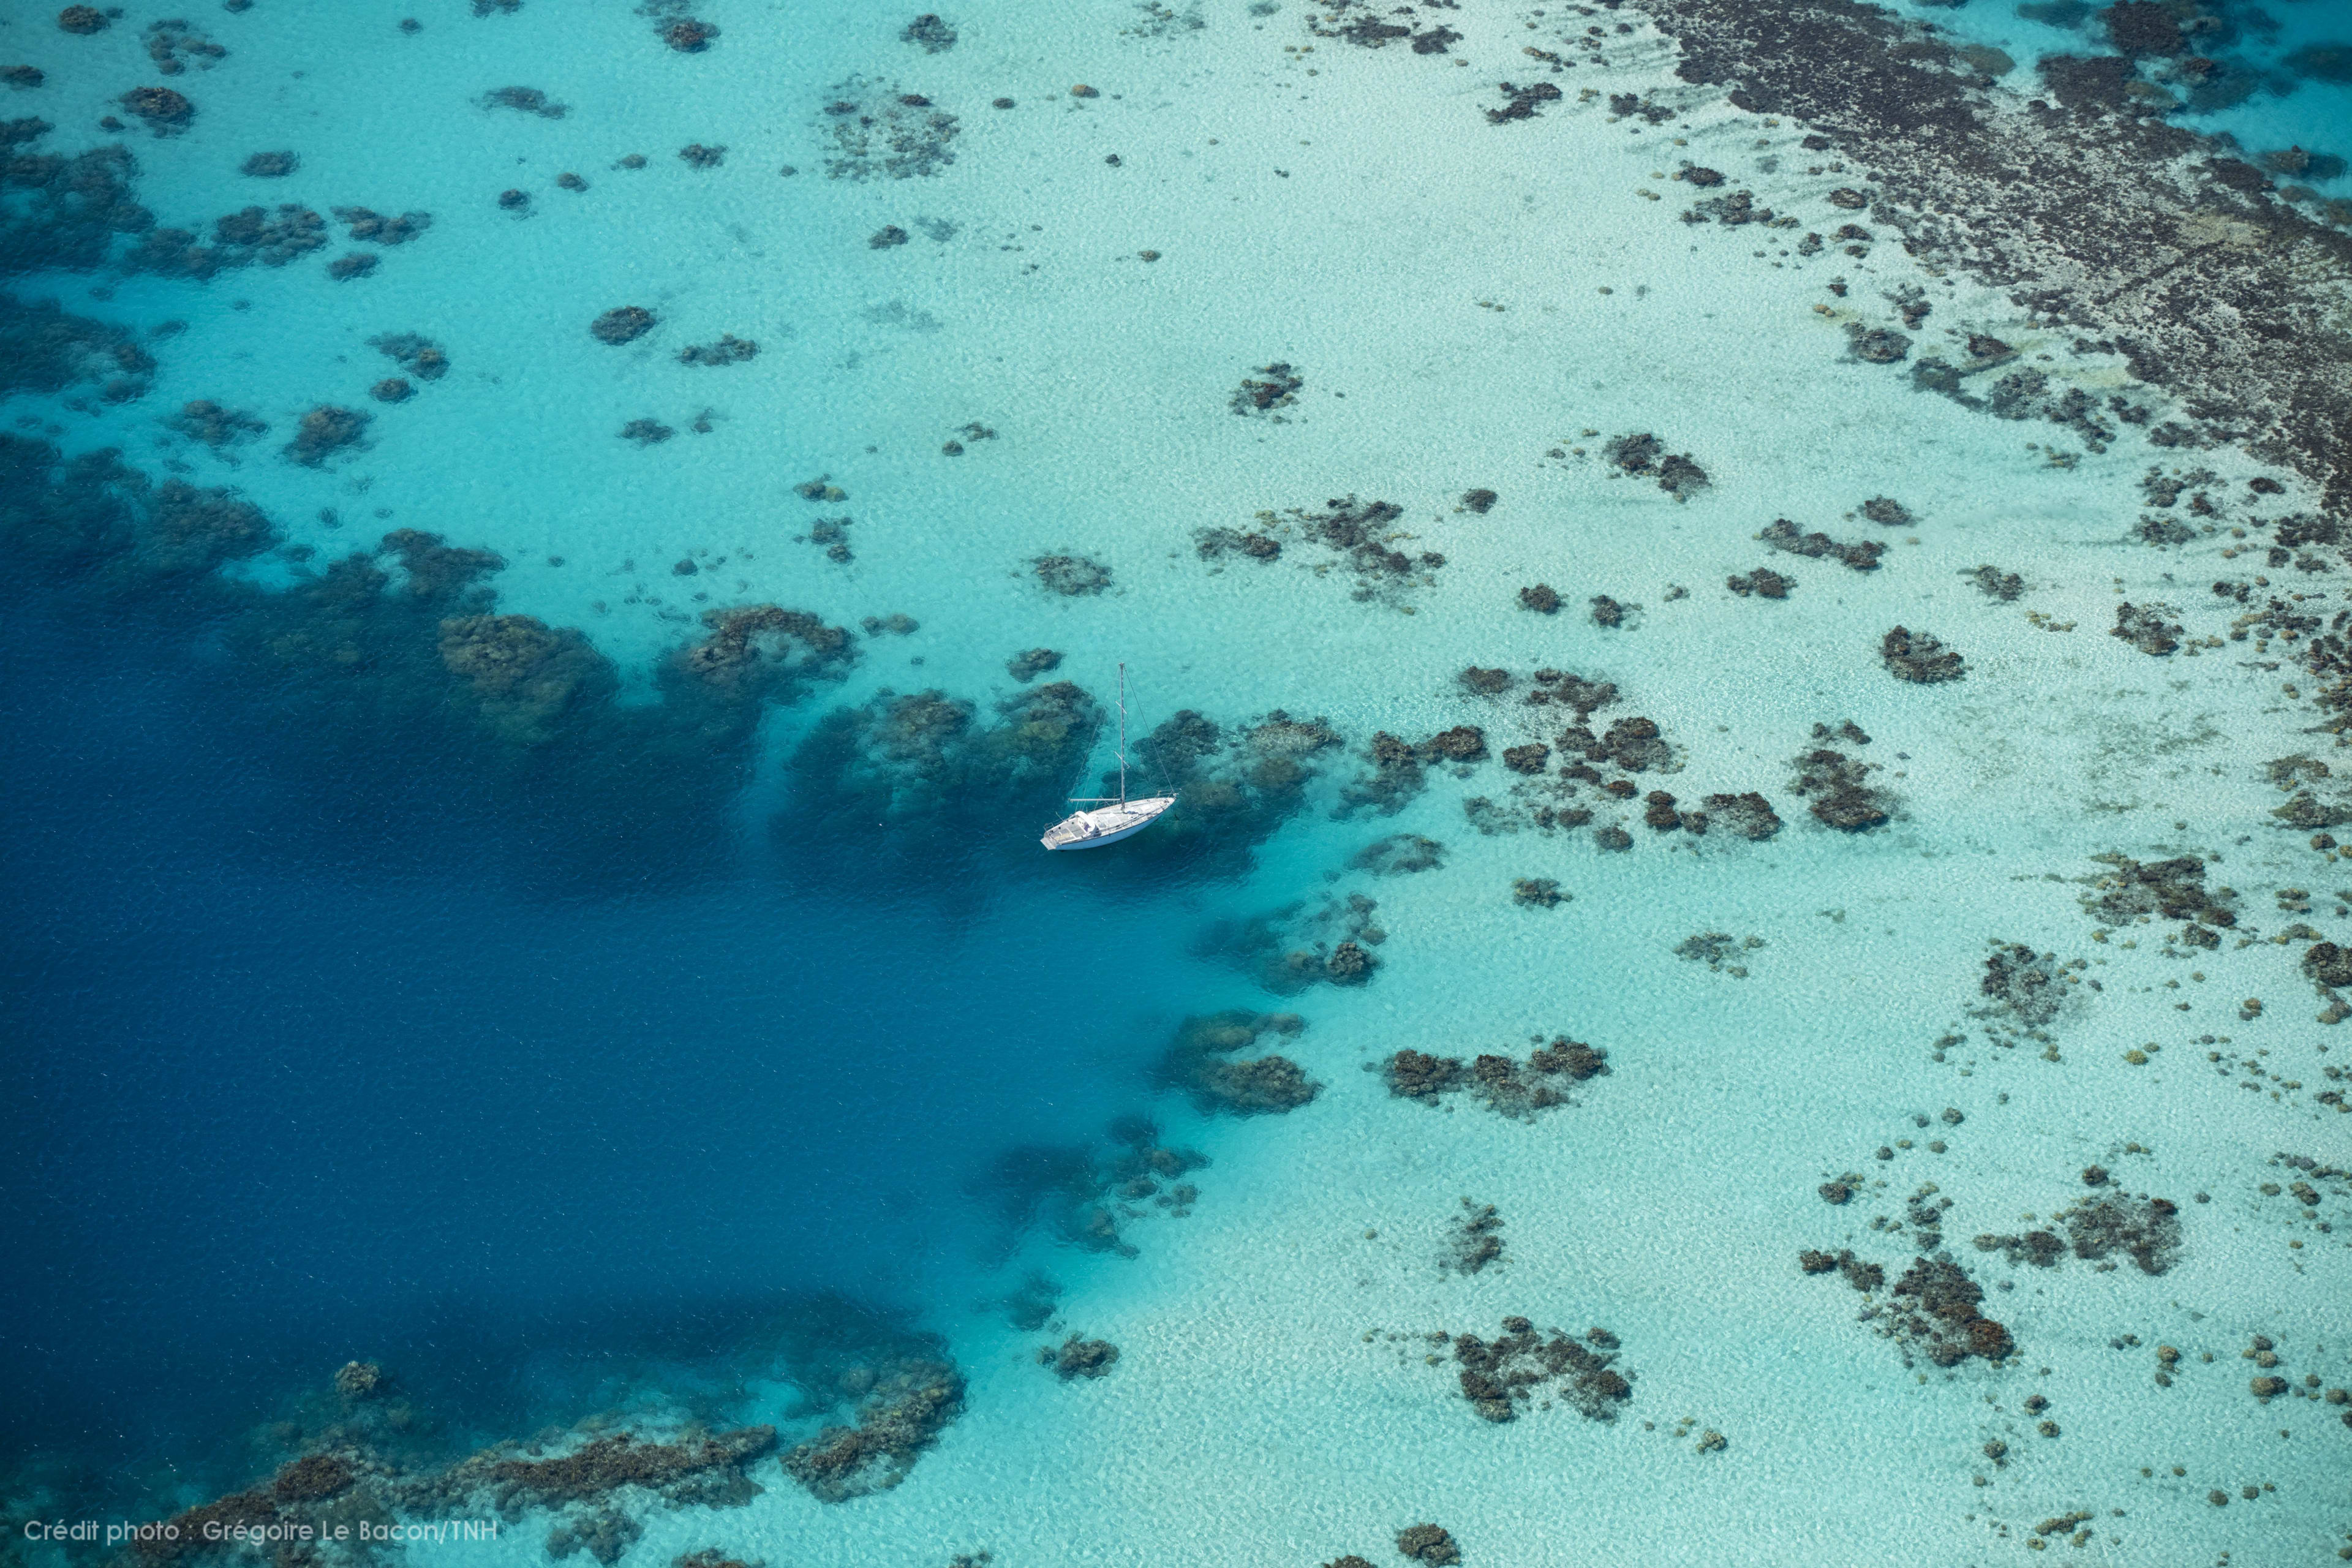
[1635,0,2352,513]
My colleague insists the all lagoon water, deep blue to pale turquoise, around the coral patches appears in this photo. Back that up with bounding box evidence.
[0,0,2352,1568]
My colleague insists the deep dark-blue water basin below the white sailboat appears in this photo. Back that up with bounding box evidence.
[0,595,1204,1453]
